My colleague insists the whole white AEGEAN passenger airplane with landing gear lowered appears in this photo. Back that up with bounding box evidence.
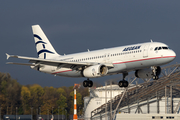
[6,25,176,87]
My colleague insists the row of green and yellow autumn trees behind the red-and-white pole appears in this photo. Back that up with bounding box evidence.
[0,73,89,115]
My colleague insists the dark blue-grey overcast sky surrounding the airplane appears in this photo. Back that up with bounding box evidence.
[0,0,180,87]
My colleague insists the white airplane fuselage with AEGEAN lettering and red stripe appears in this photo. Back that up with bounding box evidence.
[36,42,176,77]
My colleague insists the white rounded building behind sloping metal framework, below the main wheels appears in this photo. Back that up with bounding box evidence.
[84,85,133,120]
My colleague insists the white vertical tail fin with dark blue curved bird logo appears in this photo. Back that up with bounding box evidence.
[32,25,59,59]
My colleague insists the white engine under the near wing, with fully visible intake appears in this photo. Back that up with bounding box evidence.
[83,64,108,78]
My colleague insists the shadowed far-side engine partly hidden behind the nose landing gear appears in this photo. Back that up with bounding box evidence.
[135,66,161,79]
